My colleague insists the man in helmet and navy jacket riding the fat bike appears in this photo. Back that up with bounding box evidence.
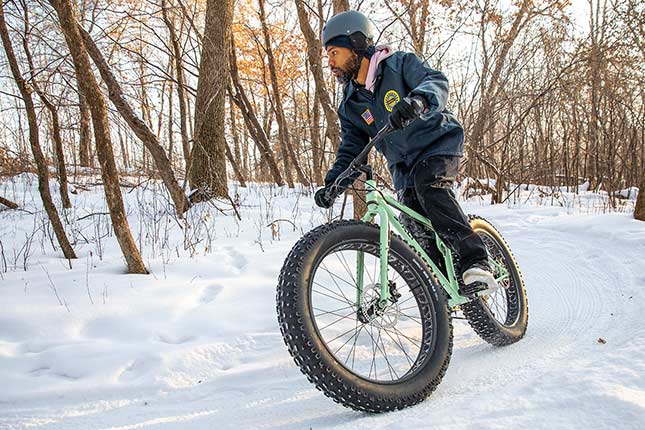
[314,11,499,295]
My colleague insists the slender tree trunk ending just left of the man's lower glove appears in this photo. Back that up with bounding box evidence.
[258,0,309,186]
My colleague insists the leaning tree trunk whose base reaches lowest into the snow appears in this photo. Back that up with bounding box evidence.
[50,0,148,273]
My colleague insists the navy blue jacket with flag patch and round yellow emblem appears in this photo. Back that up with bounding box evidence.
[325,52,464,190]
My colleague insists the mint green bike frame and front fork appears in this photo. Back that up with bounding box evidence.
[356,179,508,308]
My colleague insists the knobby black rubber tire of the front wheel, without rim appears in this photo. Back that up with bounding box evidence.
[277,220,452,412]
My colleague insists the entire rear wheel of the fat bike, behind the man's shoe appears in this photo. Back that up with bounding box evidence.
[461,215,529,346]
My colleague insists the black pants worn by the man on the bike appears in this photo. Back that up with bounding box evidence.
[398,155,488,274]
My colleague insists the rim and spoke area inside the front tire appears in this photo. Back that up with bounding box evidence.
[309,241,435,384]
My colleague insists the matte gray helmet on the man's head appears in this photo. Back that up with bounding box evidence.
[322,10,376,52]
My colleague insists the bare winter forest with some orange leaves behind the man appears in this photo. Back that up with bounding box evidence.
[0,0,645,273]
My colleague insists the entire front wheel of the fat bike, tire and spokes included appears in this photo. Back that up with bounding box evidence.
[277,220,452,412]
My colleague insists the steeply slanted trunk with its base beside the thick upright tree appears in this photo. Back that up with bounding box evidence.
[78,25,190,216]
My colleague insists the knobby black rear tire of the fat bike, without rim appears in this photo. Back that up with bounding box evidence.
[461,215,529,346]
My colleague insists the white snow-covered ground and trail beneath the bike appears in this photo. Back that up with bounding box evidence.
[0,183,645,430]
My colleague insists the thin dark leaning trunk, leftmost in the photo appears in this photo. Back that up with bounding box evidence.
[0,4,76,259]
